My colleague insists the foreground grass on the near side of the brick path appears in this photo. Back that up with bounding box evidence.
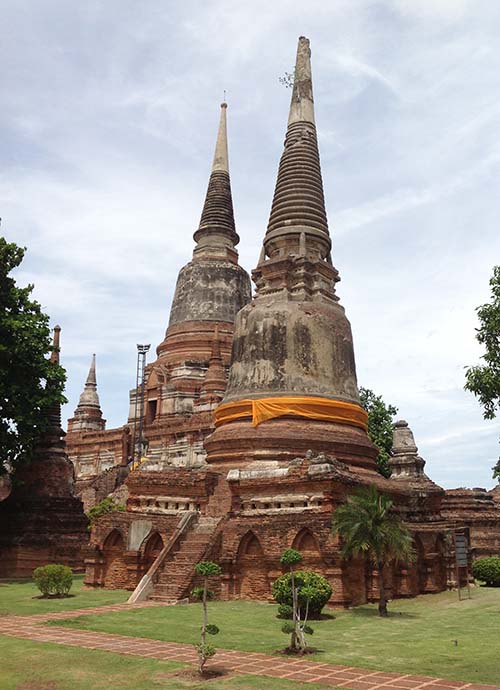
[0,636,331,690]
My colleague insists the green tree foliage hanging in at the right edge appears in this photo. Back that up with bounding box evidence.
[464,266,500,479]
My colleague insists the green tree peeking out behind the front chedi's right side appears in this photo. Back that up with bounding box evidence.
[359,388,398,477]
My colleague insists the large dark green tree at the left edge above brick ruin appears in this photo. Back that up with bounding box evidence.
[0,237,66,473]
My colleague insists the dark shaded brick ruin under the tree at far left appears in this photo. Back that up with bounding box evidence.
[0,326,89,577]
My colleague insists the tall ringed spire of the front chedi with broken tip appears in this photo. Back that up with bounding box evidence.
[264,36,331,260]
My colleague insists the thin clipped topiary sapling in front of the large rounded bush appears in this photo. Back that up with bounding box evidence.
[273,549,314,654]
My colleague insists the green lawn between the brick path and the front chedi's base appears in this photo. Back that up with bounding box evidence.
[49,588,500,685]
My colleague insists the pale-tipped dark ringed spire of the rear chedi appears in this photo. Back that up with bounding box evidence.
[194,103,240,256]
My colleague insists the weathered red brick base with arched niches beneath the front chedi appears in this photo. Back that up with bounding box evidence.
[87,458,452,605]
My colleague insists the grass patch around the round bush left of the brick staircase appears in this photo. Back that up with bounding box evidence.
[0,575,130,616]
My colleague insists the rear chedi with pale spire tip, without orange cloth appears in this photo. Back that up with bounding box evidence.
[129,98,250,469]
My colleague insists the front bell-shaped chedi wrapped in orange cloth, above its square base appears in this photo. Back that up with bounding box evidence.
[206,38,376,470]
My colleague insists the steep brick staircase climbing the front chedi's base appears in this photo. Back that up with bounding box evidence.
[149,516,221,604]
